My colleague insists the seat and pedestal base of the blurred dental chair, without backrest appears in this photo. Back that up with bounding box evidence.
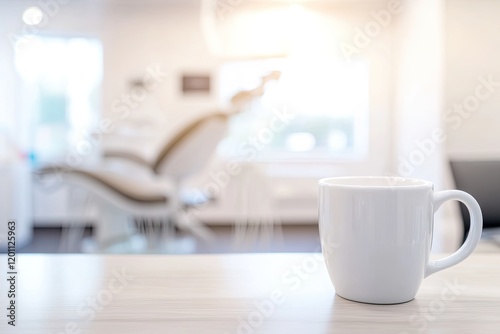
[35,166,173,252]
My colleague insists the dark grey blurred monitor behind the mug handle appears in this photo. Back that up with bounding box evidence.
[450,160,500,240]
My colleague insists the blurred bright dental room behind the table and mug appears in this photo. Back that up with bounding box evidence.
[0,0,500,253]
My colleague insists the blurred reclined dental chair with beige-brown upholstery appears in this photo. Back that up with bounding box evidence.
[35,112,230,251]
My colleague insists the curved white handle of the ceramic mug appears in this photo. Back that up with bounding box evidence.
[424,190,483,278]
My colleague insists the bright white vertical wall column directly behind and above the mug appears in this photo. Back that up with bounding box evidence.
[394,0,446,185]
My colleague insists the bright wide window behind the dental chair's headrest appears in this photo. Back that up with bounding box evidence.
[219,58,368,161]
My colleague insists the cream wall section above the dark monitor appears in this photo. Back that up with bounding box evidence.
[444,0,500,159]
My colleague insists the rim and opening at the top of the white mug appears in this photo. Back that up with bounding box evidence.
[318,176,433,189]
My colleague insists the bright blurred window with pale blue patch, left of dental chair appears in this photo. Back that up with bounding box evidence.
[16,36,102,162]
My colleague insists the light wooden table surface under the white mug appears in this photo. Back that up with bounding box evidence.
[0,253,500,334]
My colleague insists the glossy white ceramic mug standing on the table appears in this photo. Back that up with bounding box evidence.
[319,177,483,304]
